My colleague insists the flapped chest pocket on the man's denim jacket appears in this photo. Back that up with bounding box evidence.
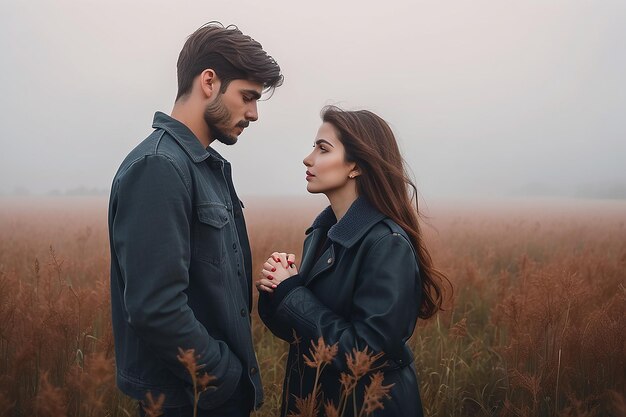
[193,204,229,265]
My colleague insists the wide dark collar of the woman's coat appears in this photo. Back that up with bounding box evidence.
[307,196,385,248]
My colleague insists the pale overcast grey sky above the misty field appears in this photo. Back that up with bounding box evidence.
[0,0,626,198]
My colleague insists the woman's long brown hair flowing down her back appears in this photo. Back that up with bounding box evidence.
[321,106,451,318]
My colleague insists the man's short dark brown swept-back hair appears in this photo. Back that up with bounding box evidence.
[176,22,283,100]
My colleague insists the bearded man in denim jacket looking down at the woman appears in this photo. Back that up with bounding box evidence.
[109,22,283,416]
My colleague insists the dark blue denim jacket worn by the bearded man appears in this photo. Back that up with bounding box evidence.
[109,112,263,409]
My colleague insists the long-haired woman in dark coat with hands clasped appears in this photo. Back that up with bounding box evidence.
[256,106,446,416]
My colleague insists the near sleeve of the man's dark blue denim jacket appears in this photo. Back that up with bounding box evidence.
[111,155,242,405]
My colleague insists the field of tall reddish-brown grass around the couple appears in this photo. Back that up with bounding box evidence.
[0,198,626,417]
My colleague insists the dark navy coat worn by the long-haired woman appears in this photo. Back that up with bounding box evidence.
[259,197,422,417]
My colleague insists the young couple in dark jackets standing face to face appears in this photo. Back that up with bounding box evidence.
[109,22,445,416]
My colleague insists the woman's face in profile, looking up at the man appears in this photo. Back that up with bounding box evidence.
[302,123,356,194]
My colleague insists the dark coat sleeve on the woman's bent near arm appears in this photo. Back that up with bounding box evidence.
[258,234,421,371]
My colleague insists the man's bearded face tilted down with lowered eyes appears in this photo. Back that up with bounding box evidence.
[204,80,263,145]
